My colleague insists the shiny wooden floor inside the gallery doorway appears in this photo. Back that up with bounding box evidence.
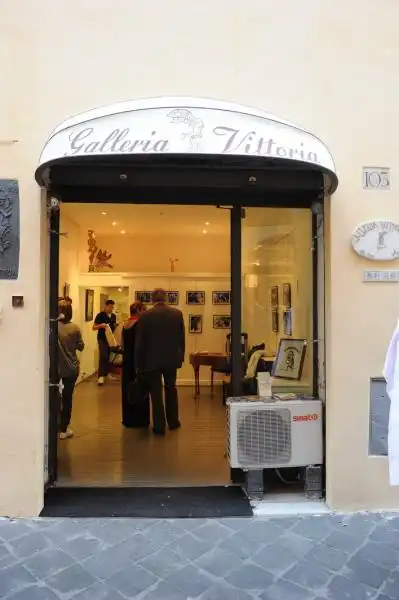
[58,381,230,486]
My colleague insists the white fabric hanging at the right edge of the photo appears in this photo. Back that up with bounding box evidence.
[383,321,399,485]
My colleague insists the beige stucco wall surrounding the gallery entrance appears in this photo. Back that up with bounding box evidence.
[0,0,399,515]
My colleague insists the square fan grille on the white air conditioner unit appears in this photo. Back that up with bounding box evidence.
[237,408,292,467]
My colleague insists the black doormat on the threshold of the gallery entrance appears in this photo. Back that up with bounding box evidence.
[40,486,253,519]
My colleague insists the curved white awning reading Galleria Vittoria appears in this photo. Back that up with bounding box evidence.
[36,97,338,193]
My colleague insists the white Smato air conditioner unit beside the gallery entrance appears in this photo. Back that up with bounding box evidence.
[227,398,323,470]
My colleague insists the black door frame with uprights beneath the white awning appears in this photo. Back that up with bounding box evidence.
[47,161,324,485]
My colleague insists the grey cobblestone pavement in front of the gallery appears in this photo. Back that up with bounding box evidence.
[0,514,399,600]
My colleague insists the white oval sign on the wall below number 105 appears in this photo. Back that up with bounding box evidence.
[352,219,399,260]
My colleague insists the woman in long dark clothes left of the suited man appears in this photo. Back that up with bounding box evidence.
[122,302,150,427]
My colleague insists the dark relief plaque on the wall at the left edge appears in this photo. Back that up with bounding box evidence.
[0,179,19,279]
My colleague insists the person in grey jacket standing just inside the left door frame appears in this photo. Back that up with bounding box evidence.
[58,298,85,440]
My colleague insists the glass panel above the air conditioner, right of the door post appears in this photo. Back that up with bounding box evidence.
[241,207,315,394]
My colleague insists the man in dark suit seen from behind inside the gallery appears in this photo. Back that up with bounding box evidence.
[135,289,185,435]
